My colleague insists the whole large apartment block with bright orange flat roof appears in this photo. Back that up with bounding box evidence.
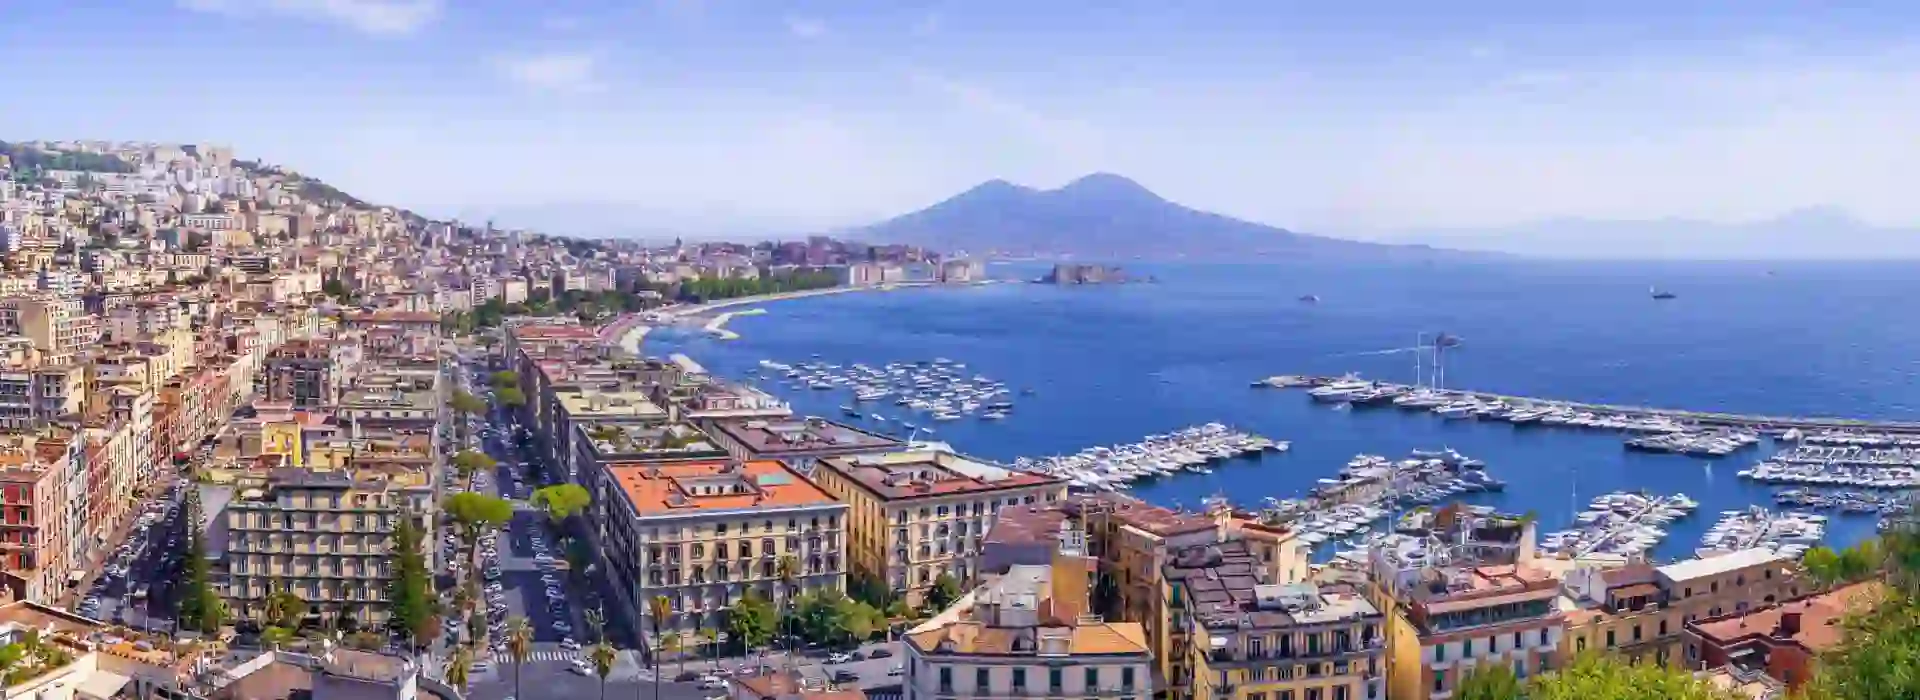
[593,456,847,635]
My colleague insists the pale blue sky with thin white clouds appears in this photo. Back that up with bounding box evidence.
[0,0,1920,238]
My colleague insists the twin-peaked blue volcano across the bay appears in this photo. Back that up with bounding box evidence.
[843,173,1428,259]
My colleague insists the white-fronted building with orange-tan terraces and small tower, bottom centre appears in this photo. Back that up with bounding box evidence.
[900,527,1154,700]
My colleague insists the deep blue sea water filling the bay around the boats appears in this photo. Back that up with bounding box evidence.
[643,259,1920,560]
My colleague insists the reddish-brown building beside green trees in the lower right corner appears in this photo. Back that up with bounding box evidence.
[1686,581,1885,690]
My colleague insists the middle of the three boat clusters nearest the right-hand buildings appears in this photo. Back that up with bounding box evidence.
[1540,491,1699,560]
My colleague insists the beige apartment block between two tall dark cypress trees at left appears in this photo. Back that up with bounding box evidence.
[207,468,434,625]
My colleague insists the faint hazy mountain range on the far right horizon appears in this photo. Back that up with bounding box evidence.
[1392,207,1920,261]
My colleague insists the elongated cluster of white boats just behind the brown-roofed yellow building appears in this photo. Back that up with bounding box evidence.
[1012,422,1290,491]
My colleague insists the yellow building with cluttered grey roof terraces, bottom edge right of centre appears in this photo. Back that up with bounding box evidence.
[1164,541,1386,700]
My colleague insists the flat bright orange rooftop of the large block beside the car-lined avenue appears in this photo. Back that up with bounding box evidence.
[609,460,839,516]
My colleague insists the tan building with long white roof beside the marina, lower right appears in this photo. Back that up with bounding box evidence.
[1561,548,1812,665]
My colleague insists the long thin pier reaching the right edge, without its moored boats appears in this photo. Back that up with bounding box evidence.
[1256,376,1920,435]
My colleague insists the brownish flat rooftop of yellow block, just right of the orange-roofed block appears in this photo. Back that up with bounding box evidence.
[820,449,1066,501]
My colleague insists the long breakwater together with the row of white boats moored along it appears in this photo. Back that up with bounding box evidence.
[1254,374,1920,433]
